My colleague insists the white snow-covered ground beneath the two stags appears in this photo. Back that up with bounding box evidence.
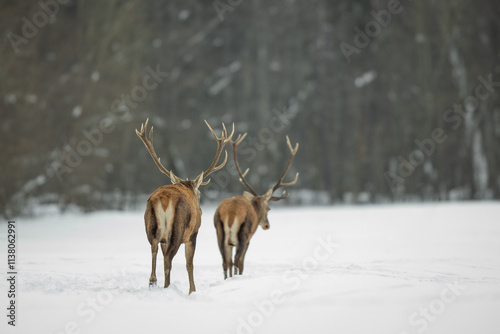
[0,203,500,334]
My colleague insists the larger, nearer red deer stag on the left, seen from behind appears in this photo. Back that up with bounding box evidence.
[135,119,234,293]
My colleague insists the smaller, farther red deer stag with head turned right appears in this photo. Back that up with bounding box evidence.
[214,133,299,279]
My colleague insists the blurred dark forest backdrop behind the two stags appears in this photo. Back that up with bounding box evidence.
[0,0,500,217]
